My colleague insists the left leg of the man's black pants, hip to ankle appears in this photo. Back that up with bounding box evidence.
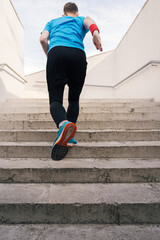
[46,47,68,127]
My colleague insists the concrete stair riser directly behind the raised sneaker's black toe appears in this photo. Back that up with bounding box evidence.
[0,146,160,158]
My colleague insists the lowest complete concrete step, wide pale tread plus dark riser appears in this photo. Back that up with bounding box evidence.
[0,183,160,224]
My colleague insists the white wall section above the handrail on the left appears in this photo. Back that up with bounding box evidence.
[0,0,24,76]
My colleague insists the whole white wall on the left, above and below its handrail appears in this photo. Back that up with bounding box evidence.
[0,0,24,101]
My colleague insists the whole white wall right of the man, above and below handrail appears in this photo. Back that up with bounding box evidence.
[24,0,160,100]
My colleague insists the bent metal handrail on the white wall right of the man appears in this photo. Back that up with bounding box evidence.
[85,60,160,88]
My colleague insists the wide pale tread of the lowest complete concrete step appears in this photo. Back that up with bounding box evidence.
[0,183,160,205]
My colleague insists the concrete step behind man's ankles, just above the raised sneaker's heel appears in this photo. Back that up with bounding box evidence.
[0,113,160,121]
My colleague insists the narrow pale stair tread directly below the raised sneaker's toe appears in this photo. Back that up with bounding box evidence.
[0,158,160,169]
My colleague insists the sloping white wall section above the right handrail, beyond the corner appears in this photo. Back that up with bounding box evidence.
[115,0,160,83]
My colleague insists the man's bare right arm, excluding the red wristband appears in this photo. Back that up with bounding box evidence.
[83,17,103,51]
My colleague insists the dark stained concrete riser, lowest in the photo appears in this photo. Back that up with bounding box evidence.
[0,203,160,224]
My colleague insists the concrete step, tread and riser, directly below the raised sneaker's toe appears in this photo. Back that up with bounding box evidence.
[0,158,160,183]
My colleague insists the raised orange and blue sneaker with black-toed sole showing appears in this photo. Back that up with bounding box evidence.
[51,121,77,161]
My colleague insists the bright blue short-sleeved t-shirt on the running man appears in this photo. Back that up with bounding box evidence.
[44,16,89,52]
